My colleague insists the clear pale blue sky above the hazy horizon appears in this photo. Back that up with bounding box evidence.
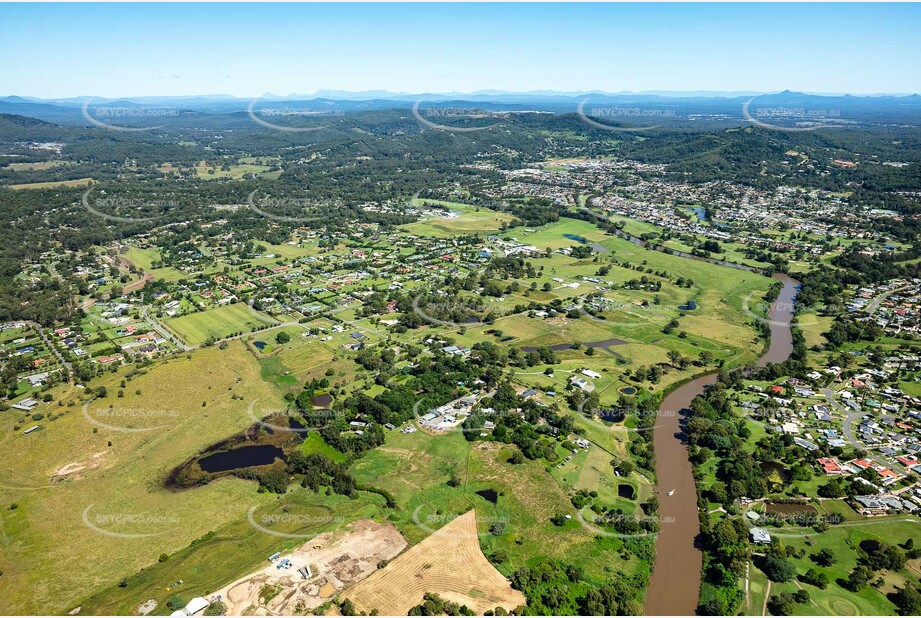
[0,4,921,97]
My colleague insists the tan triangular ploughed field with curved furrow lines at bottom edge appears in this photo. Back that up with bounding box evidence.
[344,510,525,616]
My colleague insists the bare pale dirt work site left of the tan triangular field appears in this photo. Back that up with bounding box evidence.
[209,519,407,616]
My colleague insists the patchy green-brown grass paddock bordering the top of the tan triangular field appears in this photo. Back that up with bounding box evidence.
[352,431,648,581]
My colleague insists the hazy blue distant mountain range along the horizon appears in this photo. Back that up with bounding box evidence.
[0,90,921,126]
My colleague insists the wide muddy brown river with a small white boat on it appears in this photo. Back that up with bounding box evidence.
[645,274,799,616]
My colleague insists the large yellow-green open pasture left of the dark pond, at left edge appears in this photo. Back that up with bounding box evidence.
[0,342,283,614]
